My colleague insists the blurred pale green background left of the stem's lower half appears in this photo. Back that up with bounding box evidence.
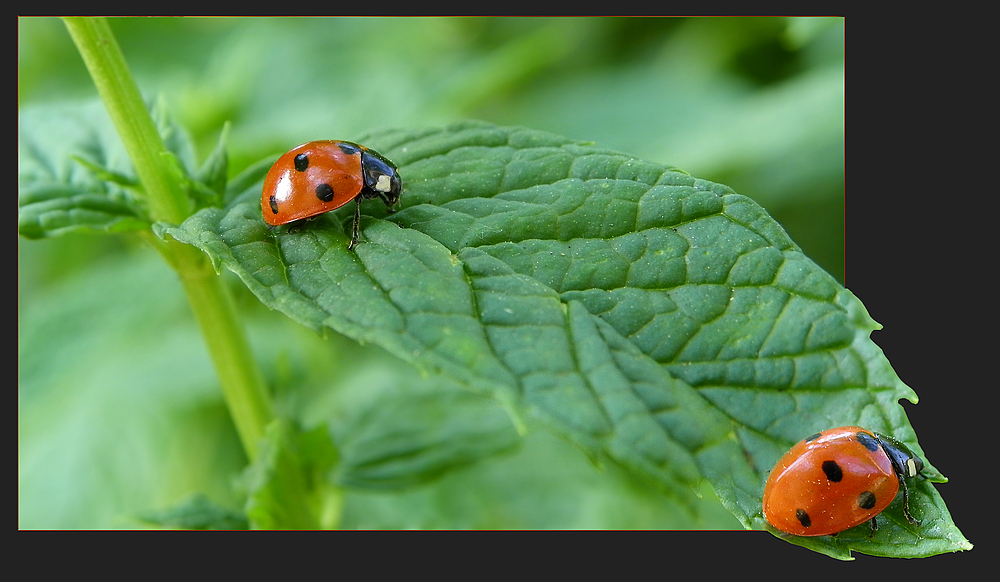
[18,253,247,529]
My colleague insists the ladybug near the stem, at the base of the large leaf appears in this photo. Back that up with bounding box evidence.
[260,140,402,249]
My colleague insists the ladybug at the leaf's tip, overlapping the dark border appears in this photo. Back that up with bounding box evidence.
[764,426,924,536]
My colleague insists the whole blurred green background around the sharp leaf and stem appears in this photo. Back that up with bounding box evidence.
[18,18,844,528]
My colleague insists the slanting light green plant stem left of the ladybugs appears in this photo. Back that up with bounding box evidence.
[65,18,274,460]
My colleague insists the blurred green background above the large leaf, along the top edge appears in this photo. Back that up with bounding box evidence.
[18,18,844,281]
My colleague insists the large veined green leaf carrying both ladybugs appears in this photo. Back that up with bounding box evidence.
[156,122,962,555]
